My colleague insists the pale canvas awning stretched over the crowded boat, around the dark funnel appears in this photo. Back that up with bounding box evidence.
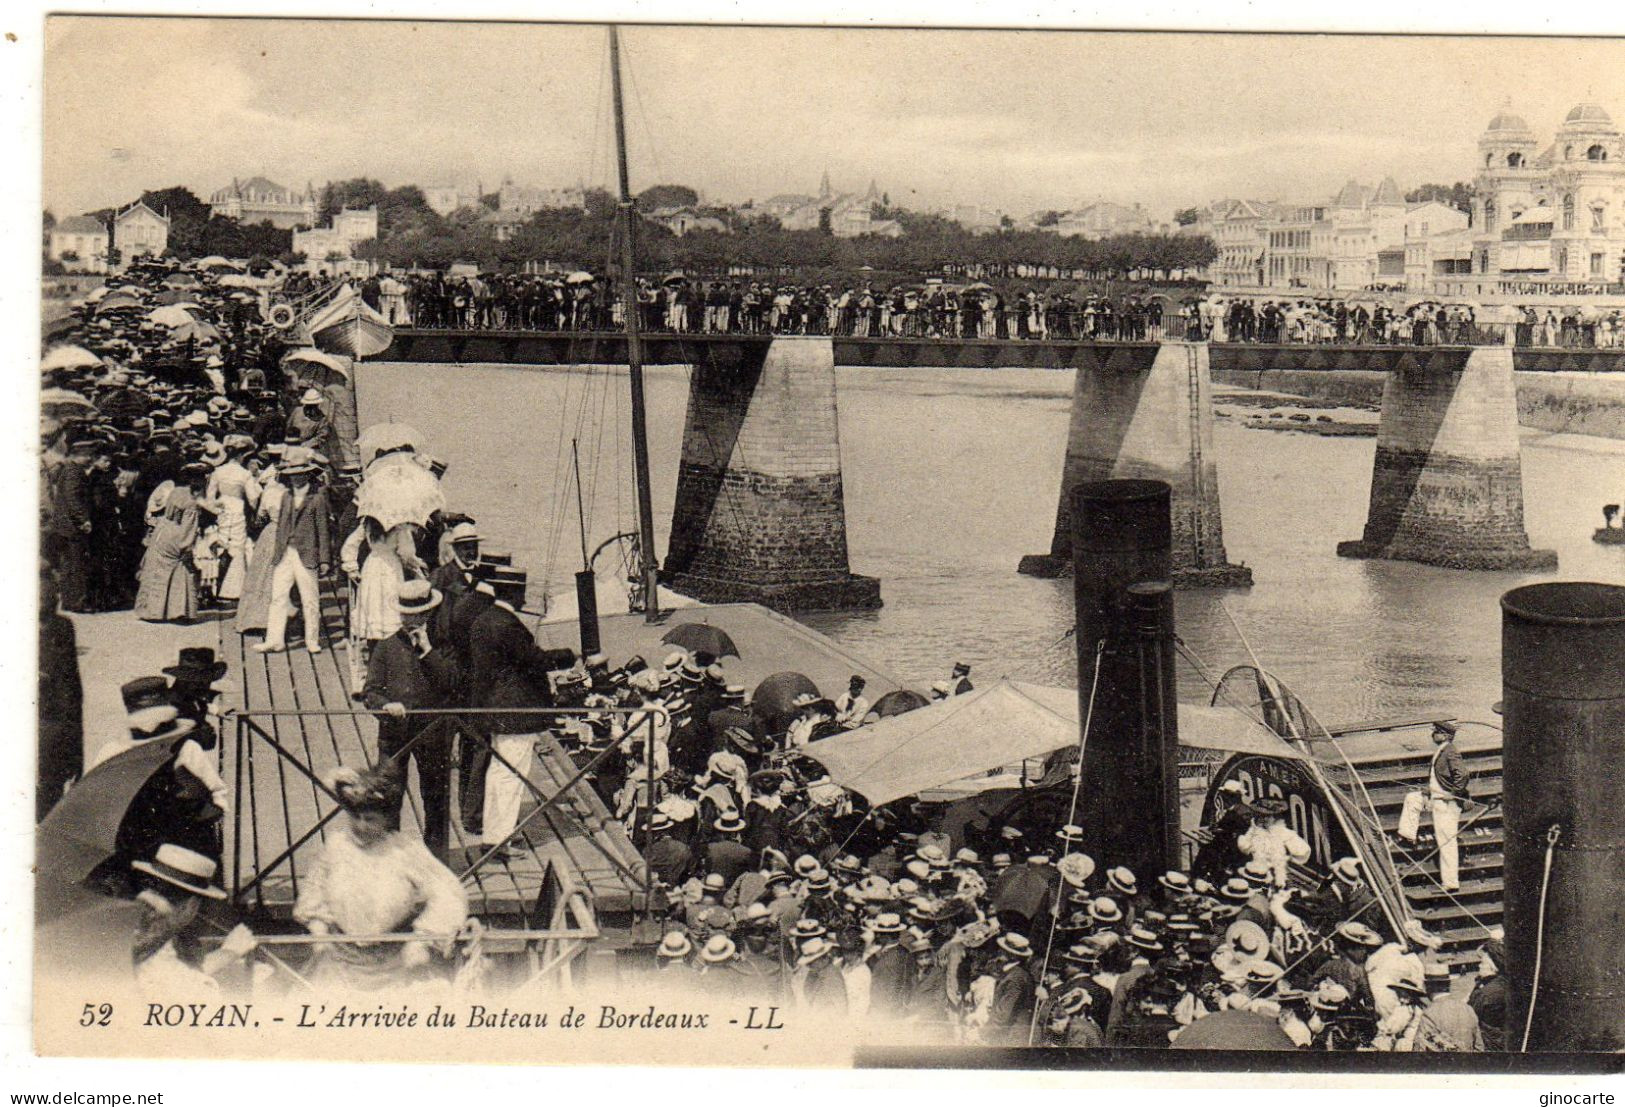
[803,679,1298,805]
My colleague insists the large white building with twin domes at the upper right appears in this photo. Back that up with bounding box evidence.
[1471,104,1625,291]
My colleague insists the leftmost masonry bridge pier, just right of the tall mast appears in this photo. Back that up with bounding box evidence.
[661,336,881,611]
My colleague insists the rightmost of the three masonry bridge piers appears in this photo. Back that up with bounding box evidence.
[1337,346,1557,569]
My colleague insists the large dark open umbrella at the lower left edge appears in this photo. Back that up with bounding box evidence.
[34,738,174,884]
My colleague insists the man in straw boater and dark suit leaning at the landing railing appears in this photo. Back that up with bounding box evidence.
[361,580,455,857]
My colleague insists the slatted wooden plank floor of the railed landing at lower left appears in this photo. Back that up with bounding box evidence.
[221,585,642,928]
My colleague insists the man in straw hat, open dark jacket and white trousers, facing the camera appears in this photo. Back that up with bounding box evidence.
[254,447,333,653]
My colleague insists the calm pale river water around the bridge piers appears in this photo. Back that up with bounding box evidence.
[358,362,1625,722]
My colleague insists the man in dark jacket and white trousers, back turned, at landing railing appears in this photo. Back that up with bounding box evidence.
[466,588,575,847]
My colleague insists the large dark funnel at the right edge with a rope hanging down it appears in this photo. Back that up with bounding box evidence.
[1502,582,1625,1052]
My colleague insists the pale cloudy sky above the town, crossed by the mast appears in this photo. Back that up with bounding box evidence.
[44,16,1625,218]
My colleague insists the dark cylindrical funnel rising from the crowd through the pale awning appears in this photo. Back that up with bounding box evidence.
[1071,480,1178,873]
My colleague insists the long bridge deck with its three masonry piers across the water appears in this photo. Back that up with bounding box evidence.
[368,328,1586,611]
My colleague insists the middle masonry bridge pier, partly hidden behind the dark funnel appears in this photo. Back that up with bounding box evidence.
[1019,341,1253,588]
